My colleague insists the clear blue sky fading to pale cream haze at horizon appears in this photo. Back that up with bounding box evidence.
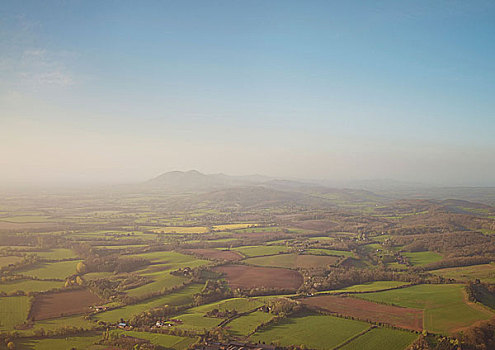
[0,0,495,186]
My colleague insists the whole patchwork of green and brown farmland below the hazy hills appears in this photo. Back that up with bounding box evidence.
[0,173,495,350]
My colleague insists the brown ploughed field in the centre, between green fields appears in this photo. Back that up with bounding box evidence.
[214,265,303,289]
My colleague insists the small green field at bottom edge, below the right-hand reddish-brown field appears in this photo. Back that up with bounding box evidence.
[341,328,418,350]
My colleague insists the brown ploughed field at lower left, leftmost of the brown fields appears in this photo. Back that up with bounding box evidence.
[30,290,102,321]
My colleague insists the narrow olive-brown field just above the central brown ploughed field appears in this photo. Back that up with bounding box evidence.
[244,254,339,269]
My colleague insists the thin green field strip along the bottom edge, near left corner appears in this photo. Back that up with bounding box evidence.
[16,333,101,350]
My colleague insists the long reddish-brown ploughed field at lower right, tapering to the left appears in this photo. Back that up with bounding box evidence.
[301,295,423,331]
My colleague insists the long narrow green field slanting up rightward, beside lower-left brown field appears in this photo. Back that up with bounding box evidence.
[95,284,203,322]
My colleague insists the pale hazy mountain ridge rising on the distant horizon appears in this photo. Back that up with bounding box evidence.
[143,170,384,207]
